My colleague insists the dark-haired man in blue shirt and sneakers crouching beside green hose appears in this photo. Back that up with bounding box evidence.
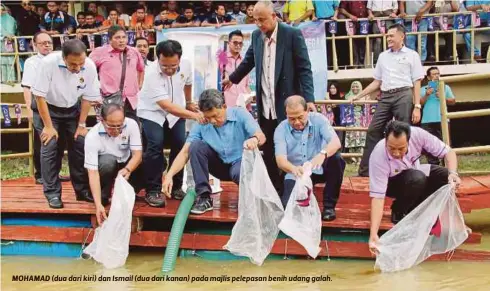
[162,89,265,214]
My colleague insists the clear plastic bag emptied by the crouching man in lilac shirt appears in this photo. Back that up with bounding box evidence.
[375,185,471,272]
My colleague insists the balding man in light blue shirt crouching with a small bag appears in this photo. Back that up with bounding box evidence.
[274,95,345,221]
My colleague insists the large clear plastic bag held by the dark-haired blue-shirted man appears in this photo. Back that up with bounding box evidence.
[223,150,284,266]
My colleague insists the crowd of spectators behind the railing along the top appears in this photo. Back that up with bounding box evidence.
[0,0,490,83]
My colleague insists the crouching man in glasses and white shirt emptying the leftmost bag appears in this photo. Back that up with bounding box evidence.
[85,103,143,225]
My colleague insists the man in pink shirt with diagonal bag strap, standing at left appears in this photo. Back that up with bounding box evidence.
[90,25,145,120]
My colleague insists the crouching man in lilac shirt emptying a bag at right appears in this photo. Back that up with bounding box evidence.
[369,121,461,249]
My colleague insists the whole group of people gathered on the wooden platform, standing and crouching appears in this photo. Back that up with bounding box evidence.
[8,1,468,254]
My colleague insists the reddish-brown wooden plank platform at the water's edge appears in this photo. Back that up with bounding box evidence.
[1,176,490,260]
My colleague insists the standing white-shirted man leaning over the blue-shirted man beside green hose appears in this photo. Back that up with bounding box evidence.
[137,40,203,207]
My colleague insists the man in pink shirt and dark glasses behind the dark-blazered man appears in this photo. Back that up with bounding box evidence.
[221,30,250,107]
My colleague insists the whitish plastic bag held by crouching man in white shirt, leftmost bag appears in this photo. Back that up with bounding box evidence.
[83,175,136,269]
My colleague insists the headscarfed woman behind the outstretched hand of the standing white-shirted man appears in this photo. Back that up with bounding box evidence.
[345,81,366,163]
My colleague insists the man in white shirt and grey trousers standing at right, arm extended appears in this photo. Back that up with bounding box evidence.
[351,24,425,177]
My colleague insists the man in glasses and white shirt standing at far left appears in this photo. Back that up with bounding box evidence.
[21,32,69,185]
